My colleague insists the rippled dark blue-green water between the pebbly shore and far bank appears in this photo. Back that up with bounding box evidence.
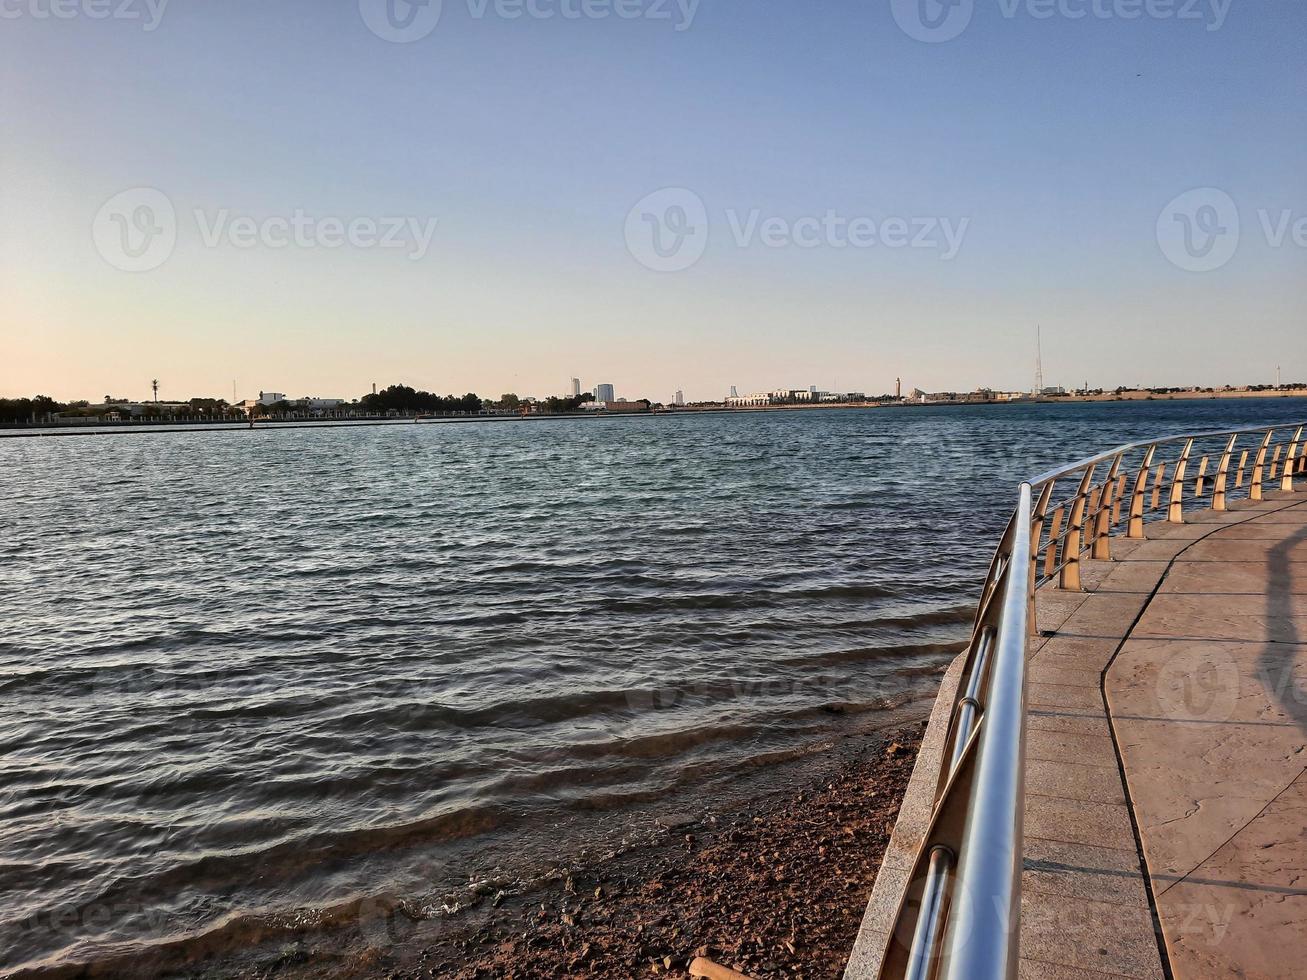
[0,400,1307,968]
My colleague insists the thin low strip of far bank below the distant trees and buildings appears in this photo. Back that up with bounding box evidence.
[0,389,1307,439]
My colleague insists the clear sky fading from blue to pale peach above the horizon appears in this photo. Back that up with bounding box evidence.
[0,0,1307,401]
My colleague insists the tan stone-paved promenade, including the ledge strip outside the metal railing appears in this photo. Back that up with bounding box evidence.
[847,493,1307,980]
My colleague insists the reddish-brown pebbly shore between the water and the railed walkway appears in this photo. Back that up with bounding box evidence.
[235,725,921,980]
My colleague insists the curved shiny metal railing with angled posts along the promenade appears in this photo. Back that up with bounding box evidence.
[880,423,1307,980]
